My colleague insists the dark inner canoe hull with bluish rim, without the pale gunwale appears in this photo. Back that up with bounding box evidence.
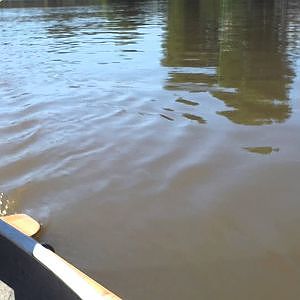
[0,220,80,300]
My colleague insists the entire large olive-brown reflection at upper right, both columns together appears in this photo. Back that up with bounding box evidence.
[162,0,295,125]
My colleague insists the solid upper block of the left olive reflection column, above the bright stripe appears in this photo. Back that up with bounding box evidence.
[162,0,219,67]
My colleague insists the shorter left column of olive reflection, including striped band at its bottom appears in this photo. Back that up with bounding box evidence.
[162,0,219,101]
